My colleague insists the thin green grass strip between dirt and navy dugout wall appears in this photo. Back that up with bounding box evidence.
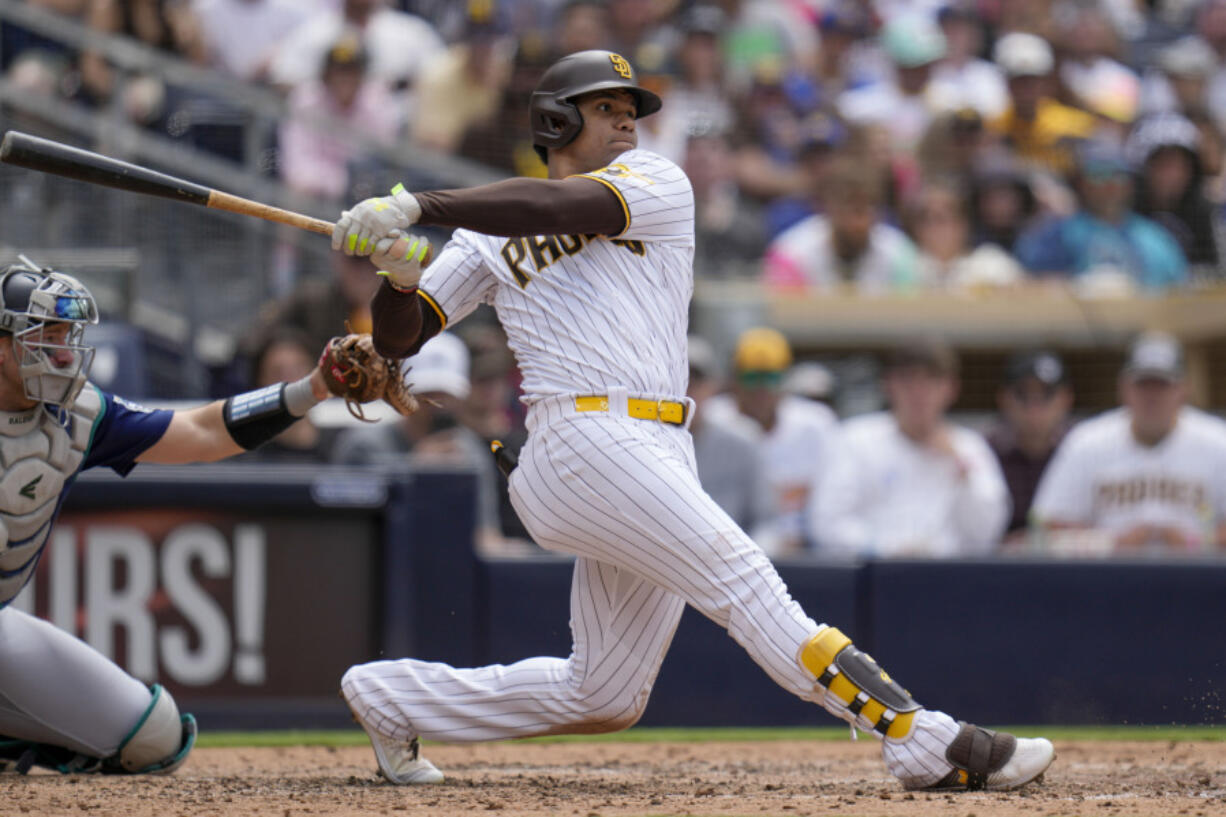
[196,725,1226,748]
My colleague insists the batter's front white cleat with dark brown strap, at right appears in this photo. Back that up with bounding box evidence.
[917,723,1056,791]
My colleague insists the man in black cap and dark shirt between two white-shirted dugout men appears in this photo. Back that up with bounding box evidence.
[988,351,1073,539]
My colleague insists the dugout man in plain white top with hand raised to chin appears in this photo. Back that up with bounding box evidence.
[809,340,1009,557]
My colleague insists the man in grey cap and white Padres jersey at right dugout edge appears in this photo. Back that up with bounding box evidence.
[1032,334,1226,553]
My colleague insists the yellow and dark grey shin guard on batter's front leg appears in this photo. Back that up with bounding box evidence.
[799,627,922,737]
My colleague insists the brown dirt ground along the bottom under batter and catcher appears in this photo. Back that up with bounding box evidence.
[0,738,1226,817]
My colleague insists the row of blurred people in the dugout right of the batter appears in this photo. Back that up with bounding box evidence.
[676,328,1226,558]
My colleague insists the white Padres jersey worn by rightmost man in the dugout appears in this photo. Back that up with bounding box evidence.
[1031,407,1226,550]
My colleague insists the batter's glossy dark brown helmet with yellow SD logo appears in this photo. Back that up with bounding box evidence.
[528,50,663,162]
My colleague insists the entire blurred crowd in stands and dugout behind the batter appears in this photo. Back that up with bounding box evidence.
[7,0,1226,557]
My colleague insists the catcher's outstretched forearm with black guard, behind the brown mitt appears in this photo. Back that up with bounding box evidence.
[137,366,330,465]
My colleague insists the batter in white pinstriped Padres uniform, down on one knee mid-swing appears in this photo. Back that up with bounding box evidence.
[332,50,1054,790]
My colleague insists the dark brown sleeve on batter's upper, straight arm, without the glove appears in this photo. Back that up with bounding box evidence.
[413,177,629,237]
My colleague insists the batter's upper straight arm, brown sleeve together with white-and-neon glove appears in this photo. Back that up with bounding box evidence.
[332,177,626,255]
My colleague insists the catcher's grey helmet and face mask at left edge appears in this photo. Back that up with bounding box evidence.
[0,256,98,410]
